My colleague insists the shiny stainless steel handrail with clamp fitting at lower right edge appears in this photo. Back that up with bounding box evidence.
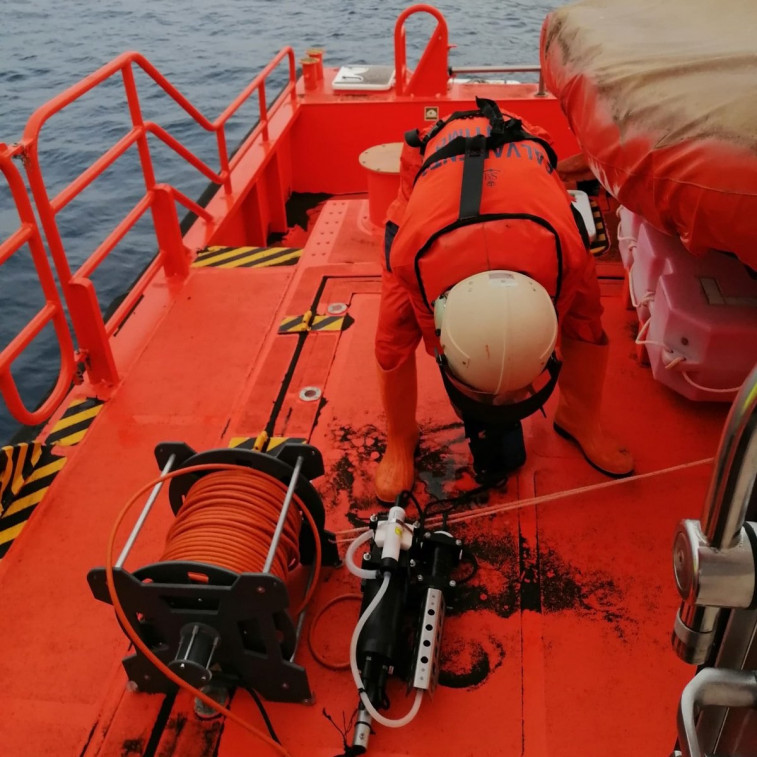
[673,367,757,757]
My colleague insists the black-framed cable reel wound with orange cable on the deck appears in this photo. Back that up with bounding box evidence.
[88,443,338,702]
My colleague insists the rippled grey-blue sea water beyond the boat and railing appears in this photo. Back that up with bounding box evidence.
[0,0,560,444]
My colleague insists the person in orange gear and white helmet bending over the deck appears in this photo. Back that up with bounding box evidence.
[375,99,633,502]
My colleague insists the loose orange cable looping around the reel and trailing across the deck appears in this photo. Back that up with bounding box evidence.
[105,463,321,757]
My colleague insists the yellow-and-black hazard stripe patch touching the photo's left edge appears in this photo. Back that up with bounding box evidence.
[0,442,66,560]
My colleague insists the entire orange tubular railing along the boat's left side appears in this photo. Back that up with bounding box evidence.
[0,47,297,423]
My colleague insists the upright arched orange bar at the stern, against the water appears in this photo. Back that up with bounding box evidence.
[394,4,450,96]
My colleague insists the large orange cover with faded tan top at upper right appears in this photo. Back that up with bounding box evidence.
[541,0,757,268]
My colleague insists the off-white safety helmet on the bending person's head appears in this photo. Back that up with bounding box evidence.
[434,271,557,405]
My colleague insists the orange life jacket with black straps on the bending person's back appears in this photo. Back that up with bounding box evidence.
[388,94,588,321]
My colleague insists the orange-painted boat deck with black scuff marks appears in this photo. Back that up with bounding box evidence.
[0,7,727,757]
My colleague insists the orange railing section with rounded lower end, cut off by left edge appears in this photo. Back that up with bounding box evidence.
[0,143,75,426]
